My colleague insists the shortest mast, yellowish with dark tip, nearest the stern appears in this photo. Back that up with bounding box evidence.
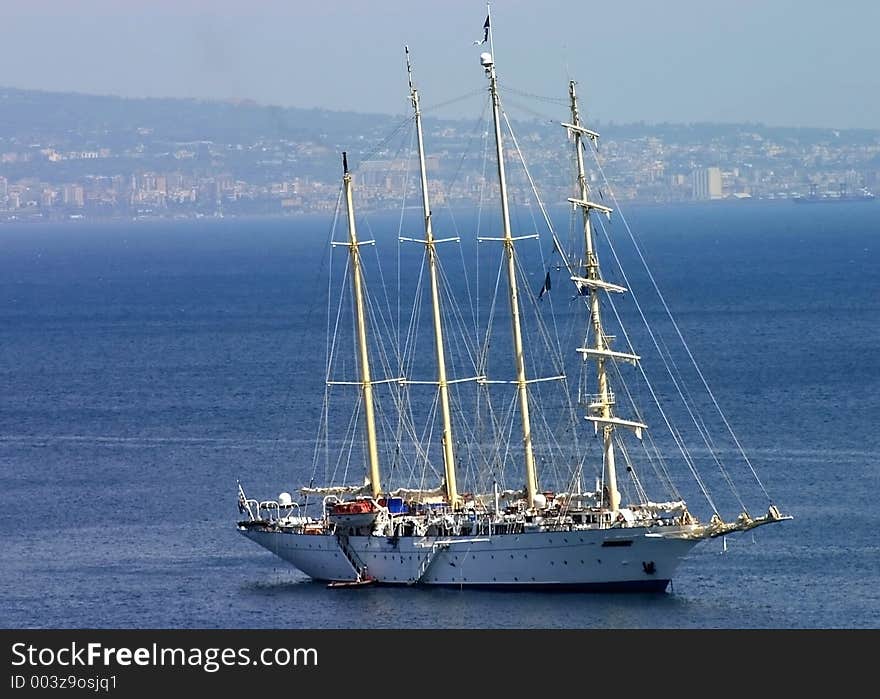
[342,151,382,498]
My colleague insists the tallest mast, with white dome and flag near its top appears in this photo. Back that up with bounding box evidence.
[480,15,538,509]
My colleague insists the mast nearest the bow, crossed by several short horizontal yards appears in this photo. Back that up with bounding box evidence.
[563,80,646,513]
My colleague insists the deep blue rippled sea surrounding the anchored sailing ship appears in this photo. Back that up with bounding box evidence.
[0,203,880,629]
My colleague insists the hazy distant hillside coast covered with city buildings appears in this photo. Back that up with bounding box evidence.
[0,88,880,225]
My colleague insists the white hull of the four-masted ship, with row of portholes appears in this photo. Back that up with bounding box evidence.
[240,527,698,592]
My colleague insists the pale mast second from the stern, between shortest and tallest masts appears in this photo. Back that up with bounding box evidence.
[406,47,459,509]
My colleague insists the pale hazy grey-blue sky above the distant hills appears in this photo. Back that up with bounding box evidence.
[0,0,880,128]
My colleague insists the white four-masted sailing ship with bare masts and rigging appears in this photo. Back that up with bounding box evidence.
[237,12,790,591]
